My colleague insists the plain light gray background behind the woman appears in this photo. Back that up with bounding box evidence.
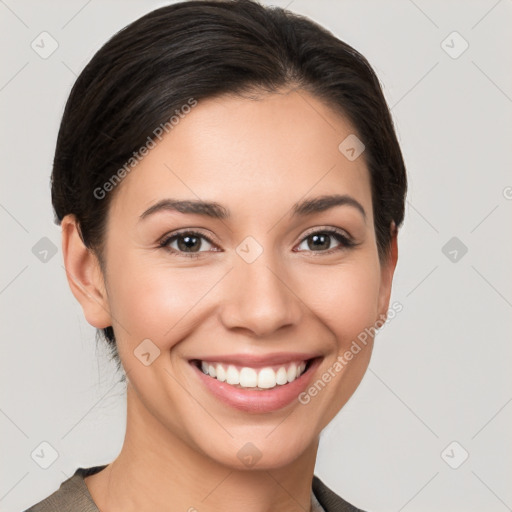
[0,0,512,512]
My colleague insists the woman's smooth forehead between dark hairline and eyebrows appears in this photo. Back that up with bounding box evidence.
[111,90,372,224]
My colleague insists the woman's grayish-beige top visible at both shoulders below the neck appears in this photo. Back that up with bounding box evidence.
[25,466,364,512]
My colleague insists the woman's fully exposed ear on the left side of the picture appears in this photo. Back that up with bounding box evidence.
[61,214,112,329]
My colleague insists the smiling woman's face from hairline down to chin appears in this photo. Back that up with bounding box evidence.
[64,86,396,468]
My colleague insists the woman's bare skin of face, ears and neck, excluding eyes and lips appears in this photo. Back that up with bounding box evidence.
[62,90,397,512]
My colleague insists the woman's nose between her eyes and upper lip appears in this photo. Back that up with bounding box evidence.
[221,251,305,337]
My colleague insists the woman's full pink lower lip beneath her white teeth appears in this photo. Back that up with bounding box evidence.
[190,358,321,413]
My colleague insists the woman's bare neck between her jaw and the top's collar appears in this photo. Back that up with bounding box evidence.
[86,384,318,512]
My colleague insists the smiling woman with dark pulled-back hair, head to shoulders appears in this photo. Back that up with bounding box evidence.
[29,0,406,512]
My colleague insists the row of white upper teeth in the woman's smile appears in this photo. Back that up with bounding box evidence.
[197,361,306,389]
